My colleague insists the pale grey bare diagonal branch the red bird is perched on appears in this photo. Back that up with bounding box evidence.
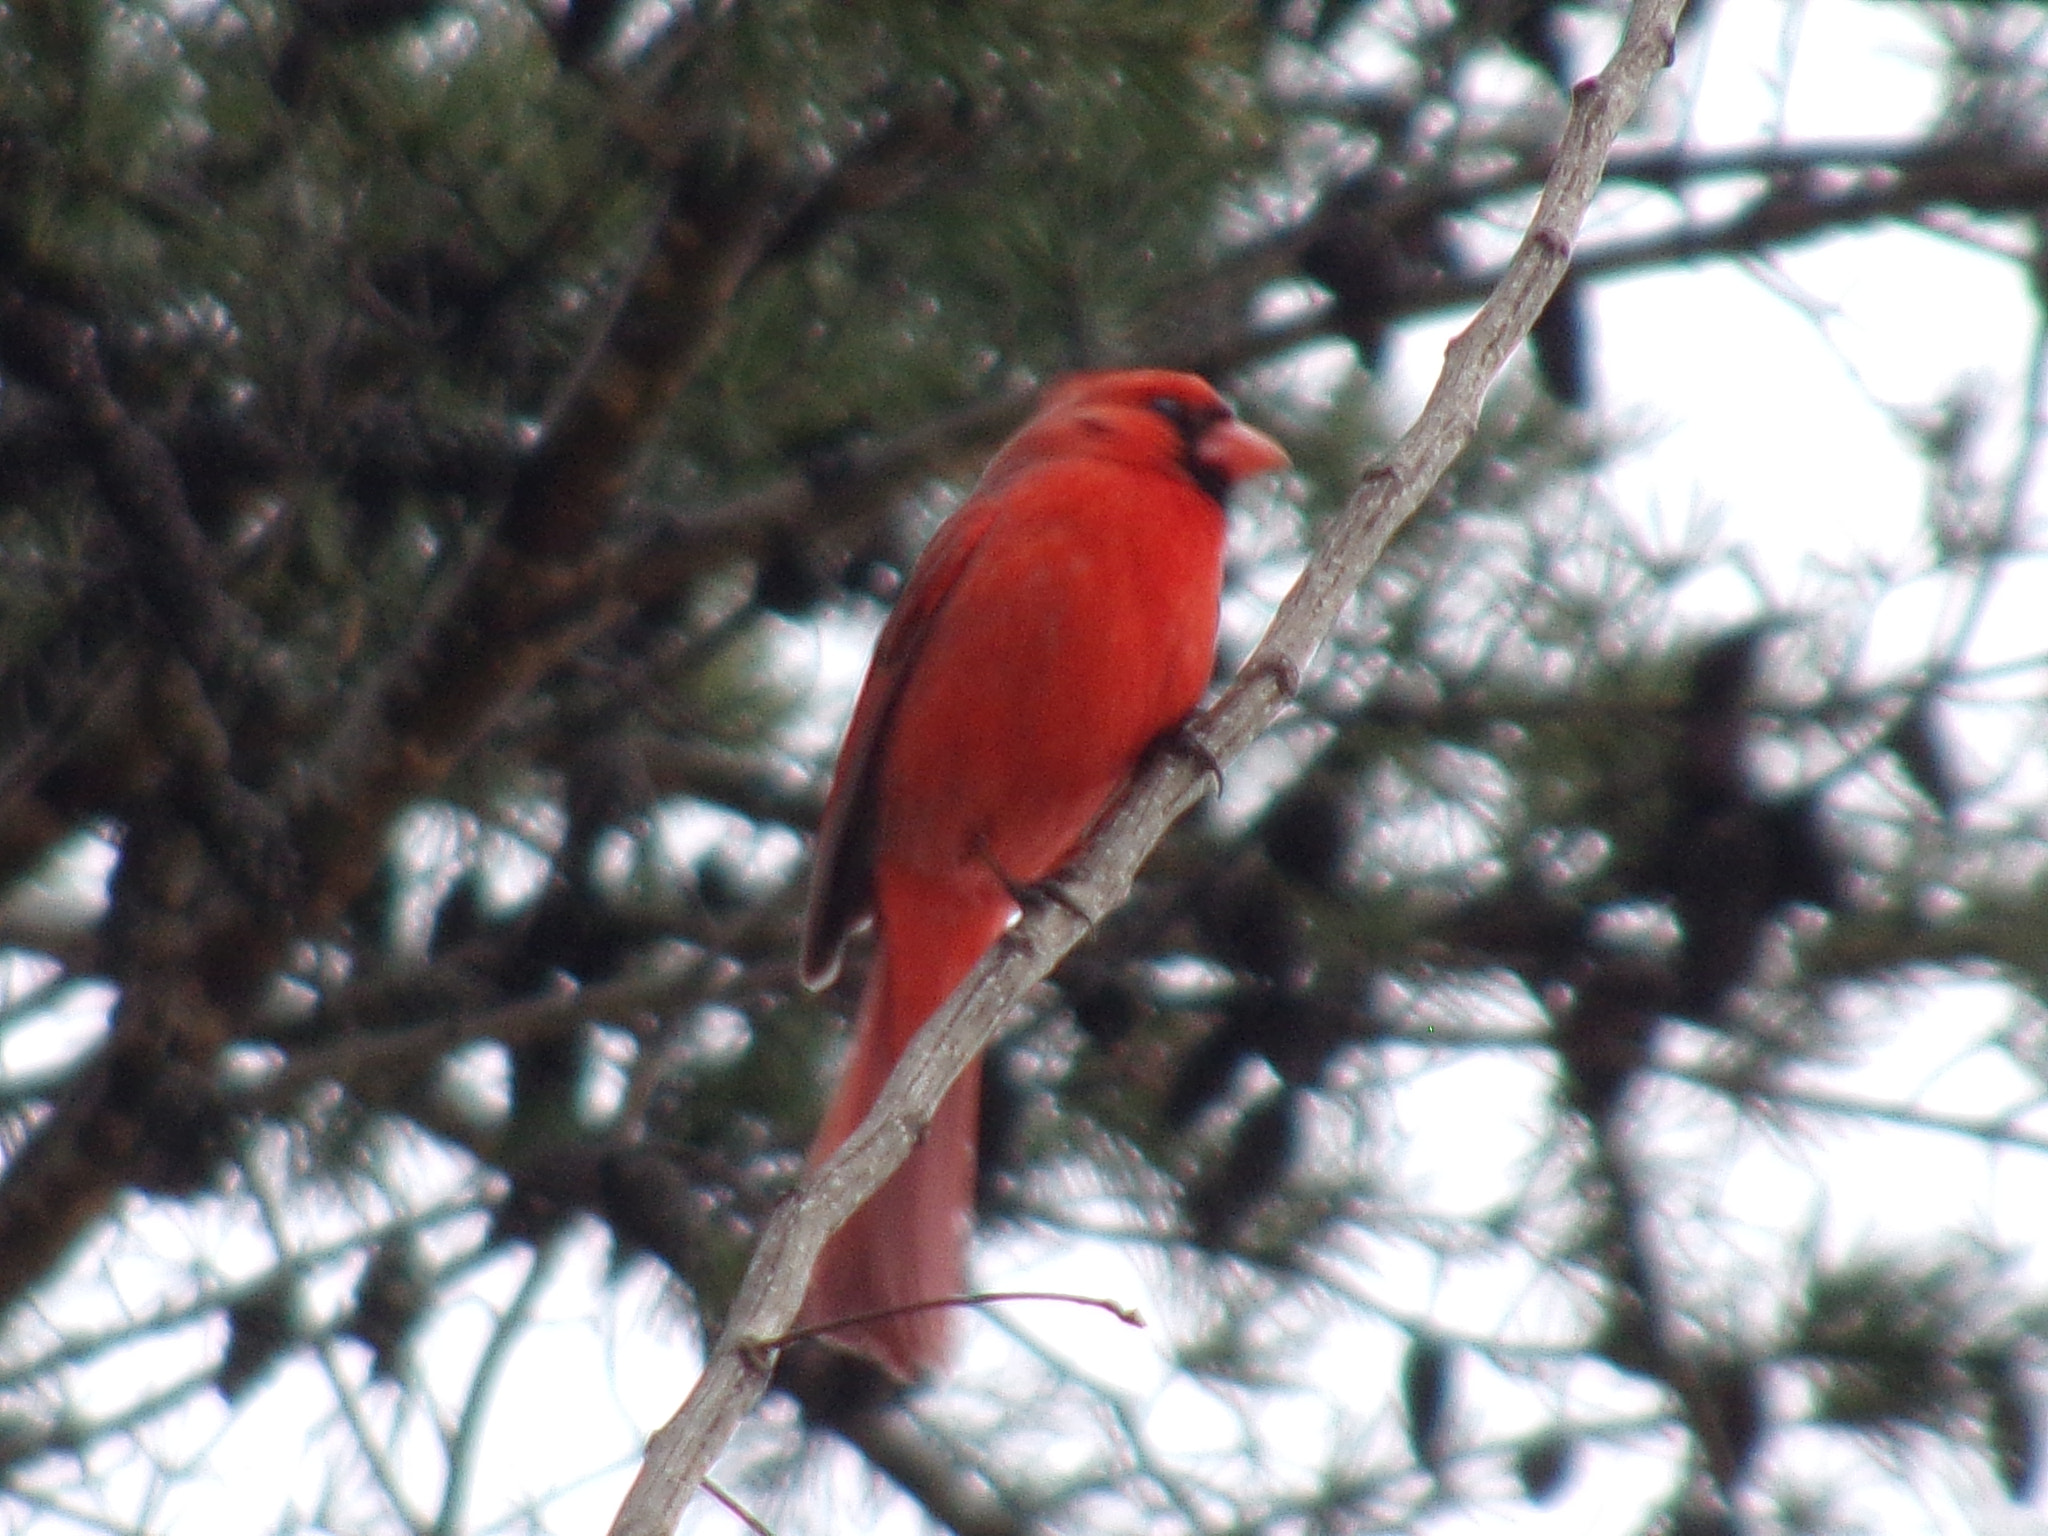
[612,0,1681,1536]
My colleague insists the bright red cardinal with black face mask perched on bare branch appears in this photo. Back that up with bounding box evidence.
[799,371,1288,1382]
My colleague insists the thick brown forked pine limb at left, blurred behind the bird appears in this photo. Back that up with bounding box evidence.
[0,93,983,1335]
